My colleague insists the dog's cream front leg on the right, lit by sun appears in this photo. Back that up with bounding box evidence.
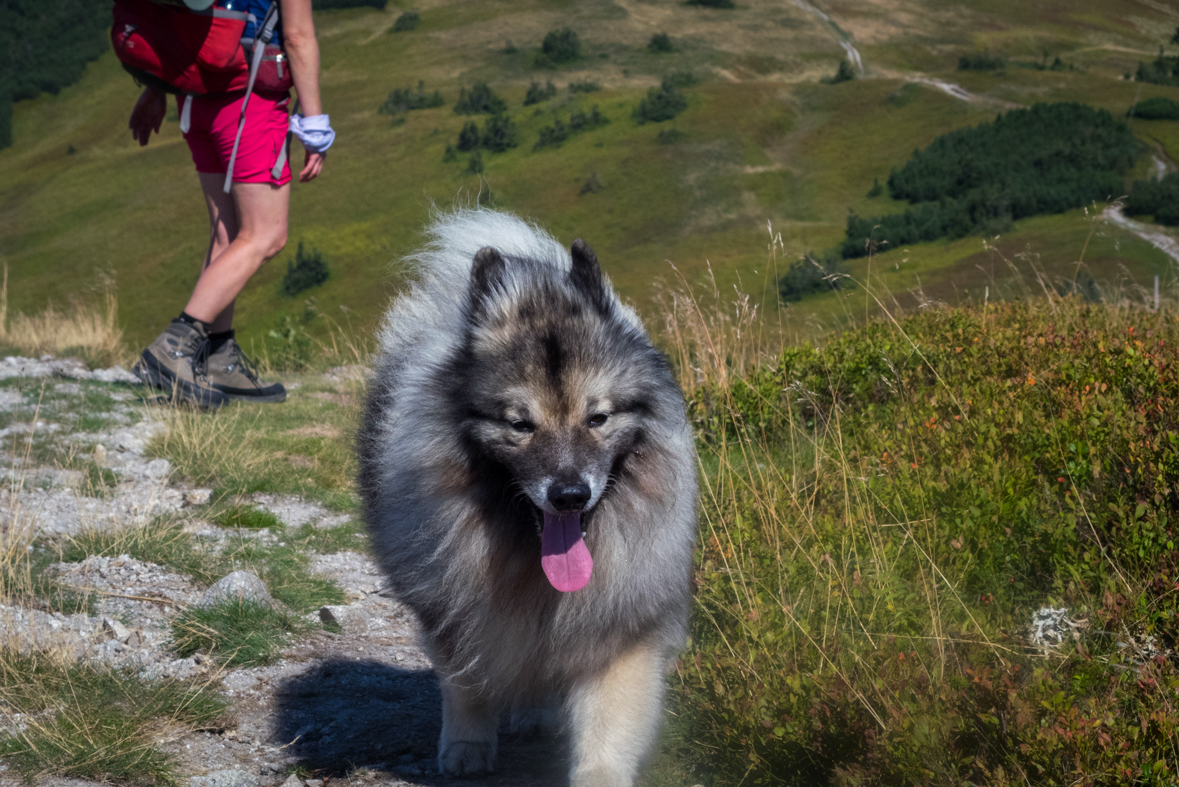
[568,646,664,787]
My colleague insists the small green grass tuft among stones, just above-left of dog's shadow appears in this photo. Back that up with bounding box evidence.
[171,600,311,667]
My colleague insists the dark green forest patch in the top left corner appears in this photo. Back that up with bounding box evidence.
[0,0,111,150]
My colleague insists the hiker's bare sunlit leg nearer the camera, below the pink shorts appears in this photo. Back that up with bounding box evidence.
[184,180,290,331]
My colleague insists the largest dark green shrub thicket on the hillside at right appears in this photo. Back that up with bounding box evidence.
[842,104,1141,257]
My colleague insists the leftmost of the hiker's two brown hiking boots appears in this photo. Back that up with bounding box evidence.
[132,319,229,408]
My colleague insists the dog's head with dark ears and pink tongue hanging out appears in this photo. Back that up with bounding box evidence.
[463,240,673,590]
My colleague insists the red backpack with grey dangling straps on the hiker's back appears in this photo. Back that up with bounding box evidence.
[111,0,294,188]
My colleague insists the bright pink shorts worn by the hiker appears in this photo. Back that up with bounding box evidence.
[185,93,291,186]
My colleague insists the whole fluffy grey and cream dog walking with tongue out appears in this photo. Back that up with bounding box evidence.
[358,210,697,787]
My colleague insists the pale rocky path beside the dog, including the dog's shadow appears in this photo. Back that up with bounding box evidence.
[0,357,575,787]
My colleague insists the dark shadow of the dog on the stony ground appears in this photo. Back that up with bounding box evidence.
[272,659,567,786]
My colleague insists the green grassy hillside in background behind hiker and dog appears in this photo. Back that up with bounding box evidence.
[0,0,1179,351]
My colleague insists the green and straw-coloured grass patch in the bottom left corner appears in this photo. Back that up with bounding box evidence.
[0,650,225,785]
